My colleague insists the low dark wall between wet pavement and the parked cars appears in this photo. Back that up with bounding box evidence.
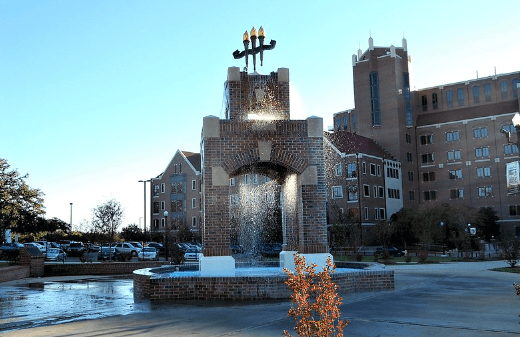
[45,261,169,276]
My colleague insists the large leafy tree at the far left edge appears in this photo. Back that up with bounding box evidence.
[0,158,45,232]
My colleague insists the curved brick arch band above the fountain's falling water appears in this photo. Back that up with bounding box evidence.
[222,148,308,176]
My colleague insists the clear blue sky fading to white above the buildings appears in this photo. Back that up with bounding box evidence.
[0,0,520,230]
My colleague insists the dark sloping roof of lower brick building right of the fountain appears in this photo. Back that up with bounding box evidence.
[324,131,395,160]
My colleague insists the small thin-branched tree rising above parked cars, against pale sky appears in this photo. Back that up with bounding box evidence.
[92,199,124,241]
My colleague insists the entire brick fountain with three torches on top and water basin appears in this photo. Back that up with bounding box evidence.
[134,29,393,300]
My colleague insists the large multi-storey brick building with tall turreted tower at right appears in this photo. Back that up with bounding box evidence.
[329,38,520,237]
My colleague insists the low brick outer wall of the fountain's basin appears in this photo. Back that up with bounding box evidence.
[134,270,394,301]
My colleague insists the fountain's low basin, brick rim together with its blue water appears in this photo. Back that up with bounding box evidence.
[133,264,394,301]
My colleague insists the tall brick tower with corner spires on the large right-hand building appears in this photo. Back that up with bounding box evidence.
[352,38,419,207]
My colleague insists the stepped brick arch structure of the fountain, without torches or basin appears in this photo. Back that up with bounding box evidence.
[201,67,328,275]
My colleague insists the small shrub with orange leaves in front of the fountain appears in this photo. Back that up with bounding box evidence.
[283,254,349,337]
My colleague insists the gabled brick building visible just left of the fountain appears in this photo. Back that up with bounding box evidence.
[150,150,201,231]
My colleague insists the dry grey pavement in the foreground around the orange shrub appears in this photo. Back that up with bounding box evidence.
[0,261,520,337]
